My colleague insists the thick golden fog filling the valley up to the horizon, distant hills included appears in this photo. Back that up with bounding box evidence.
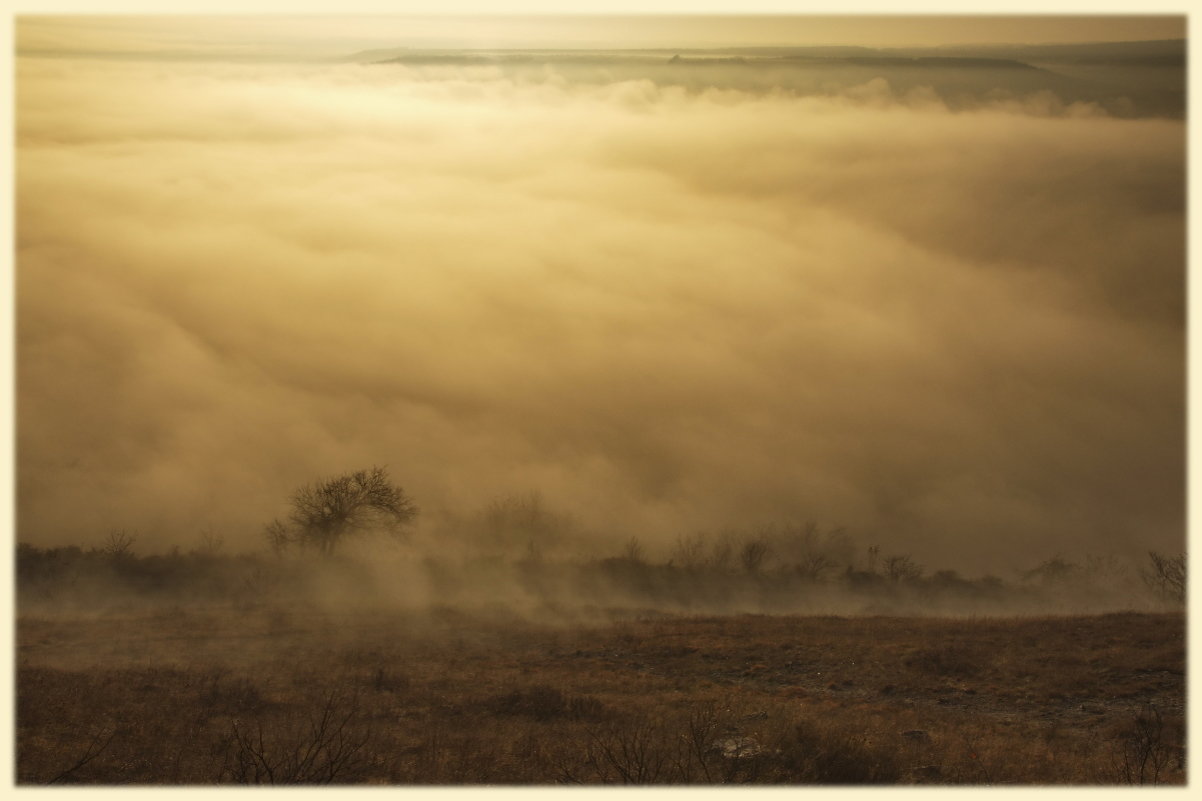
[16,20,1185,571]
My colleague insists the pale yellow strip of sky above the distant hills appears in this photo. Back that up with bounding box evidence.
[9,12,1185,57]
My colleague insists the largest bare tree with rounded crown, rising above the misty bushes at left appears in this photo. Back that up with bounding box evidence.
[267,467,418,556]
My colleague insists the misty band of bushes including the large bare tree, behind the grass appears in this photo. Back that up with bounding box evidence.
[16,468,1186,618]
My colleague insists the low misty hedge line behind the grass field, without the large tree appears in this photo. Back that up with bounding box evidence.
[16,527,1185,618]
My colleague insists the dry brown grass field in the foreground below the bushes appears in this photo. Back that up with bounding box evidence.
[17,606,1185,785]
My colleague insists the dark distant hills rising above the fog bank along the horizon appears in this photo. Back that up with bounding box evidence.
[346,40,1185,119]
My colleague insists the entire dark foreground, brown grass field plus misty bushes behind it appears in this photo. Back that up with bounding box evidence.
[16,490,1185,784]
